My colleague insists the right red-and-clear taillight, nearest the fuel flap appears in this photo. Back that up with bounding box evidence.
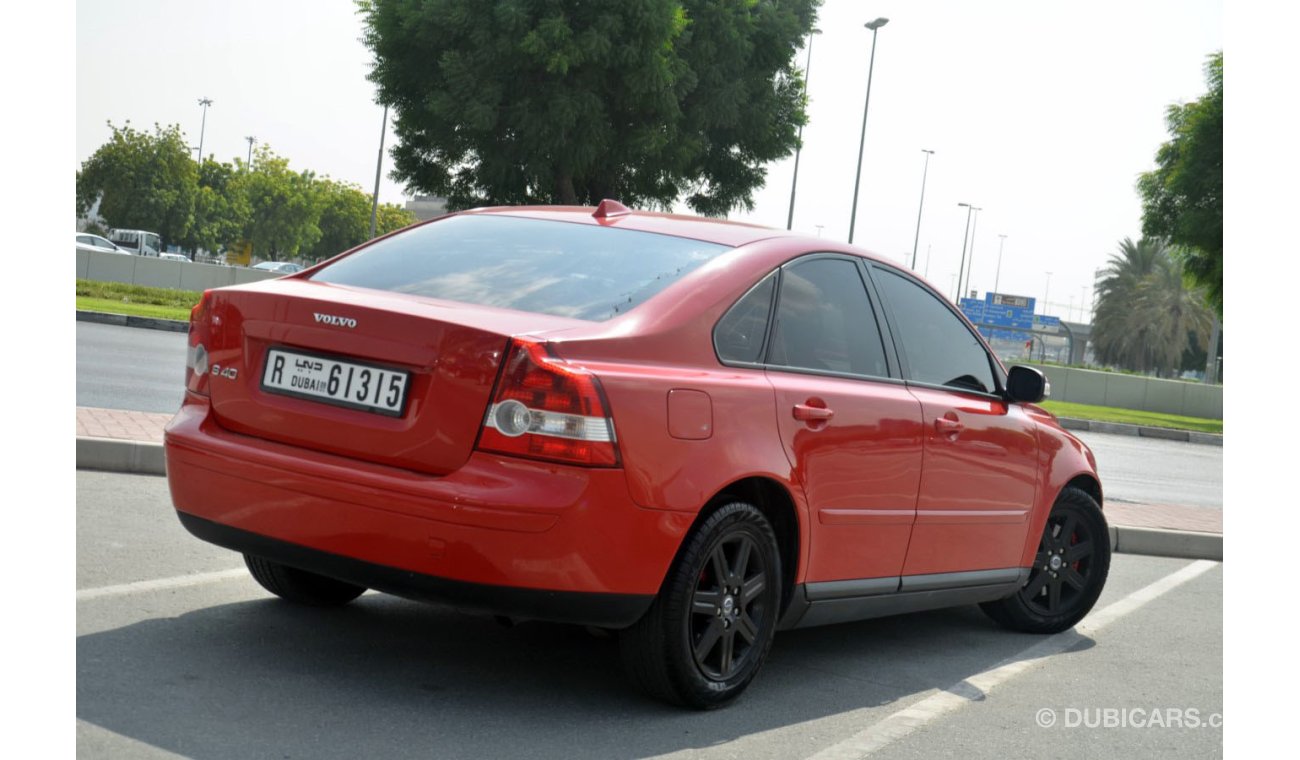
[478,339,619,466]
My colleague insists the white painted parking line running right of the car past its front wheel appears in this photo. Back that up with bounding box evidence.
[810,560,1219,760]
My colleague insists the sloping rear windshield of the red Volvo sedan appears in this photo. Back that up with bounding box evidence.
[312,214,729,321]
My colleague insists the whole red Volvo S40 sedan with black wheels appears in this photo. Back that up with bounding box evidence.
[165,201,1110,708]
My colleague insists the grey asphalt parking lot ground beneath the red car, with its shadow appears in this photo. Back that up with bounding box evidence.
[77,472,1223,759]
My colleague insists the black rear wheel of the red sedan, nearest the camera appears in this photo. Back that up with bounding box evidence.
[619,501,781,709]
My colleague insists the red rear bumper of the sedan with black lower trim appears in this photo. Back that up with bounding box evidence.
[164,395,692,627]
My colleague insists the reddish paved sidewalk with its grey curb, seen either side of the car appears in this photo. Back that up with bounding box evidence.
[77,407,1223,560]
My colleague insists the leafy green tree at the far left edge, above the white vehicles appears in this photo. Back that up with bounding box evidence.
[77,122,199,243]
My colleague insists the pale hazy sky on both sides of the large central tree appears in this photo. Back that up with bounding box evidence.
[77,0,1223,318]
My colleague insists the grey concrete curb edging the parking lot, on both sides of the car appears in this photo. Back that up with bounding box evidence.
[77,437,1223,561]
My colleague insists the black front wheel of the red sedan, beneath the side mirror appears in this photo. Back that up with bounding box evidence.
[980,487,1110,634]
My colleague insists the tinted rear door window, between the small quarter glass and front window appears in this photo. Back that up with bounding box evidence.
[767,259,889,377]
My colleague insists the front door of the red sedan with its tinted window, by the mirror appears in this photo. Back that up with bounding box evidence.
[871,265,1039,576]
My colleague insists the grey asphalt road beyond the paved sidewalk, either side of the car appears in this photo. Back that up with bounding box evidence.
[77,322,1223,509]
